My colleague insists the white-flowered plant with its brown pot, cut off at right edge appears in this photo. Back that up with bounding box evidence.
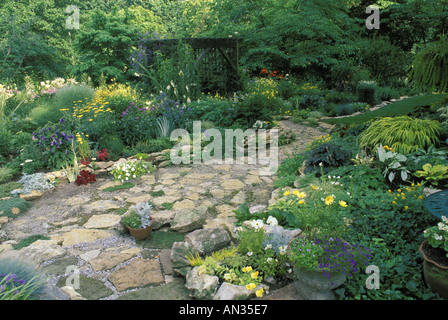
[419,216,448,299]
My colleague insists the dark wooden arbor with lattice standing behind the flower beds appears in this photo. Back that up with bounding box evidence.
[147,38,242,93]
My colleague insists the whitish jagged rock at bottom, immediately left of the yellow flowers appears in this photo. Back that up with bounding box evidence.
[185,267,219,300]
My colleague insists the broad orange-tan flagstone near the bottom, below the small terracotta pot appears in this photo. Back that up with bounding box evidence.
[108,258,164,291]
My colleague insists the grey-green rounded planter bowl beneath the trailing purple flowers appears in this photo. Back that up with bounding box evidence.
[293,268,347,300]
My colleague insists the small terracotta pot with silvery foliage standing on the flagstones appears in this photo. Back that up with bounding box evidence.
[121,202,153,240]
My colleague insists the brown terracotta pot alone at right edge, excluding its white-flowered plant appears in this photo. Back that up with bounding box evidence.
[419,240,448,299]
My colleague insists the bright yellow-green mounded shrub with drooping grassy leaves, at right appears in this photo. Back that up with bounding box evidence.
[359,116,443,154]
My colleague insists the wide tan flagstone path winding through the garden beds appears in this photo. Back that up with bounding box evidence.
[0,121,329,300]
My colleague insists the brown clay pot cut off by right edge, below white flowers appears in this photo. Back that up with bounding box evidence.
[419,241,448,299]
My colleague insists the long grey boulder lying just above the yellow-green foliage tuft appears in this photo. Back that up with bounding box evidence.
[185,227,231,255]
